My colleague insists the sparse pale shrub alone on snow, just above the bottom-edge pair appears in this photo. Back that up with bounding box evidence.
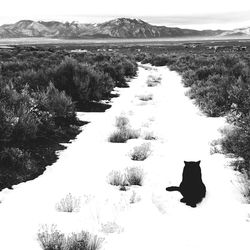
[56,193,80,213]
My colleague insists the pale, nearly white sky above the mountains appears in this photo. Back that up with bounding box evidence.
[0,0,250,29]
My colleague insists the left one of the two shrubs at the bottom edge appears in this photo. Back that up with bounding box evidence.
[38,225,65,250]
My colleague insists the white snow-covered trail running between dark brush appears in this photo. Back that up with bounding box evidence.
[0,63,250,250]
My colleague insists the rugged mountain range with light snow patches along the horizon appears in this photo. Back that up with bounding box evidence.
[0,18,250,39]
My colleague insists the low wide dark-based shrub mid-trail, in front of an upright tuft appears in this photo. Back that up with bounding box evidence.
[108,128,140,143]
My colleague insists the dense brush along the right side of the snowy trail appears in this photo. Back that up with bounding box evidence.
[137,44,250,177]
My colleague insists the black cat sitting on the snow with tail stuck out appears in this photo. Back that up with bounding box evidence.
[166,161,206,207]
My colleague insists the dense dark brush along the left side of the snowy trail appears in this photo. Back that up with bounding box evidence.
[0,46,137,190]
